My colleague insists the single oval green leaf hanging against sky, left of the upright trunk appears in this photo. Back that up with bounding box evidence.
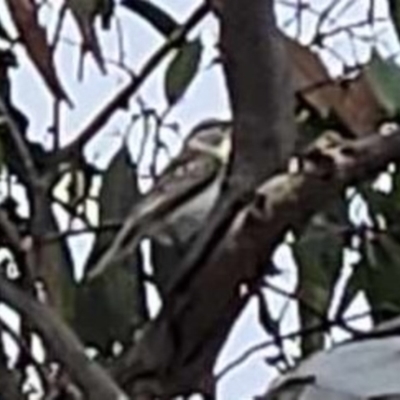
[165,40,202,105]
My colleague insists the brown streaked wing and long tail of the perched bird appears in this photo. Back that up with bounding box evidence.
[87,151,220,280]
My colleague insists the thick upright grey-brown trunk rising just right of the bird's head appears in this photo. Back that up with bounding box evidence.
[221,0,296,187]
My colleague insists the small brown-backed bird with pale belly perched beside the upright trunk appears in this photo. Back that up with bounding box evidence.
[87,119,232,280]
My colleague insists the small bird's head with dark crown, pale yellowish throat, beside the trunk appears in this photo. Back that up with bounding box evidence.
[185,120,232,164]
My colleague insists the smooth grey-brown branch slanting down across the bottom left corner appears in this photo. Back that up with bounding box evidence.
[0,275,128,400]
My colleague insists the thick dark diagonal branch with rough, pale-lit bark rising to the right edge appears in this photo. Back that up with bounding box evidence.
[112,131,400,394]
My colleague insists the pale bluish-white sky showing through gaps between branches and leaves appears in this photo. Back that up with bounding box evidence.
[0,0,399,400]
